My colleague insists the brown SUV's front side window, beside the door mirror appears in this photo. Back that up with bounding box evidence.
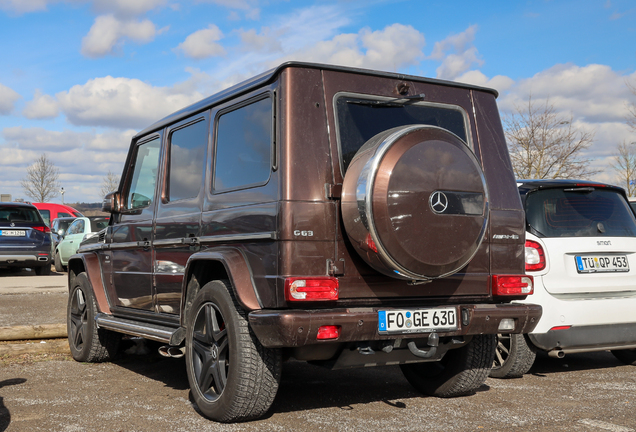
[125,137,161,210]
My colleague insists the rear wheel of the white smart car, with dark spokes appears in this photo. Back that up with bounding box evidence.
[490,334,537,378]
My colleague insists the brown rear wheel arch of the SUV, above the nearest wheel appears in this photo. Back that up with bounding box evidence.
[180,248,262,326]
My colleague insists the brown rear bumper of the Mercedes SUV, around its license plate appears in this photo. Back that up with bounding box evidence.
[249,304,541,348]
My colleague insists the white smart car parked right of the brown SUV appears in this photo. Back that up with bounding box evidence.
[490,180,636,378]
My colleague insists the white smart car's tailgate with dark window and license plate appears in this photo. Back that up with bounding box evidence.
[526,187,636,296]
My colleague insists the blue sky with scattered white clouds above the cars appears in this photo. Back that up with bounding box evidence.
[0,0,636,202]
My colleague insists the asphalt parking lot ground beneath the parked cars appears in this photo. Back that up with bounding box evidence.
[0,272,636,432]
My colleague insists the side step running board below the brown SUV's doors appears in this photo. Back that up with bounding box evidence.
[95,314,185,346]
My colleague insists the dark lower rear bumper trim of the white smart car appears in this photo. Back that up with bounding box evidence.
[528,323,636,354]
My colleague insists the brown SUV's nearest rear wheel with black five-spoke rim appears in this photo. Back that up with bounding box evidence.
[186,281,282,423]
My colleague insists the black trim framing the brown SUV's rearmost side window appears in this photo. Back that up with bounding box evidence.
[210,88,277,195]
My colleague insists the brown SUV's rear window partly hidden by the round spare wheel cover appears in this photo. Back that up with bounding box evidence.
[336,95,468,172]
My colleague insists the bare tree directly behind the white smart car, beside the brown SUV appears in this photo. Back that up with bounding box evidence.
[503,96,599,179]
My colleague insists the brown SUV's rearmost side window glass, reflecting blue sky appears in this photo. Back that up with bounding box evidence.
[213,97,273,191]
